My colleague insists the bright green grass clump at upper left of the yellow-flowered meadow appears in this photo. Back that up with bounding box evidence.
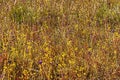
[10,3,38,25]
